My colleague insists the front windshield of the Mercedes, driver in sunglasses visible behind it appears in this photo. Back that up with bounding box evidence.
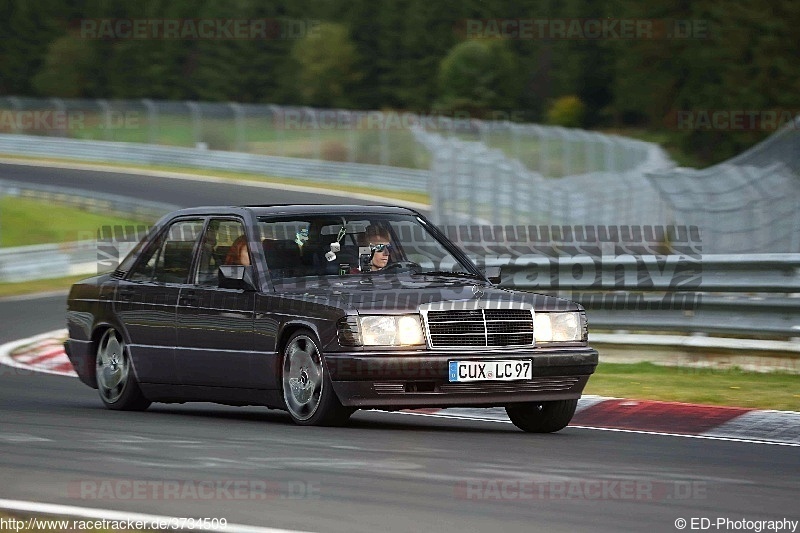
[258,213,480,280]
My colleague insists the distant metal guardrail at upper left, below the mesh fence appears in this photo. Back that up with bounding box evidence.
[0,135,429,193]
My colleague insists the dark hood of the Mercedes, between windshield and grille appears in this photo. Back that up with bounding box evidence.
[276,276,582,313]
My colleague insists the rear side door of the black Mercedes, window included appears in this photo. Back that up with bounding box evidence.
[114,219,203,383]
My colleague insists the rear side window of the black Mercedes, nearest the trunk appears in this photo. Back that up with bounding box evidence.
[129,220,203,283]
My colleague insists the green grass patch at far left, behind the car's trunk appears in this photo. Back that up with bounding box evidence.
[0,196,142,247]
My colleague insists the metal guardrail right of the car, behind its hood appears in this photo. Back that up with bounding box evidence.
[486,254,800,338]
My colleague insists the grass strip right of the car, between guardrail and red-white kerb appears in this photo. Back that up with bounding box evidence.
[585,363,800,411]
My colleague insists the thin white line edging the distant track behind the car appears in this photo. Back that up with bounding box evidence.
[0,157,431,210]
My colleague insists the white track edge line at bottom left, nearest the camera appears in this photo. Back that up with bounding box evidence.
[0,499,312,533]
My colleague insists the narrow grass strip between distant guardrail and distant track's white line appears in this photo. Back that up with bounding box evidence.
[0,154,430,204]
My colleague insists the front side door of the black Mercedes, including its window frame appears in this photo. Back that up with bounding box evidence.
[175,218,256,388]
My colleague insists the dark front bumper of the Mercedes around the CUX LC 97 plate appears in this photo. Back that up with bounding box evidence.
[325,347,598,409]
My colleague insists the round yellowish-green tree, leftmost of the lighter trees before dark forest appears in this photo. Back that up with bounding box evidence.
[292,22,361,107]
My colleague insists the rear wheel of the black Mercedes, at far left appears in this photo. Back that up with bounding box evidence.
[95,328,151,411]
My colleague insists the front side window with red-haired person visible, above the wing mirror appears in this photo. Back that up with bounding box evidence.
[194,219,251,287]
